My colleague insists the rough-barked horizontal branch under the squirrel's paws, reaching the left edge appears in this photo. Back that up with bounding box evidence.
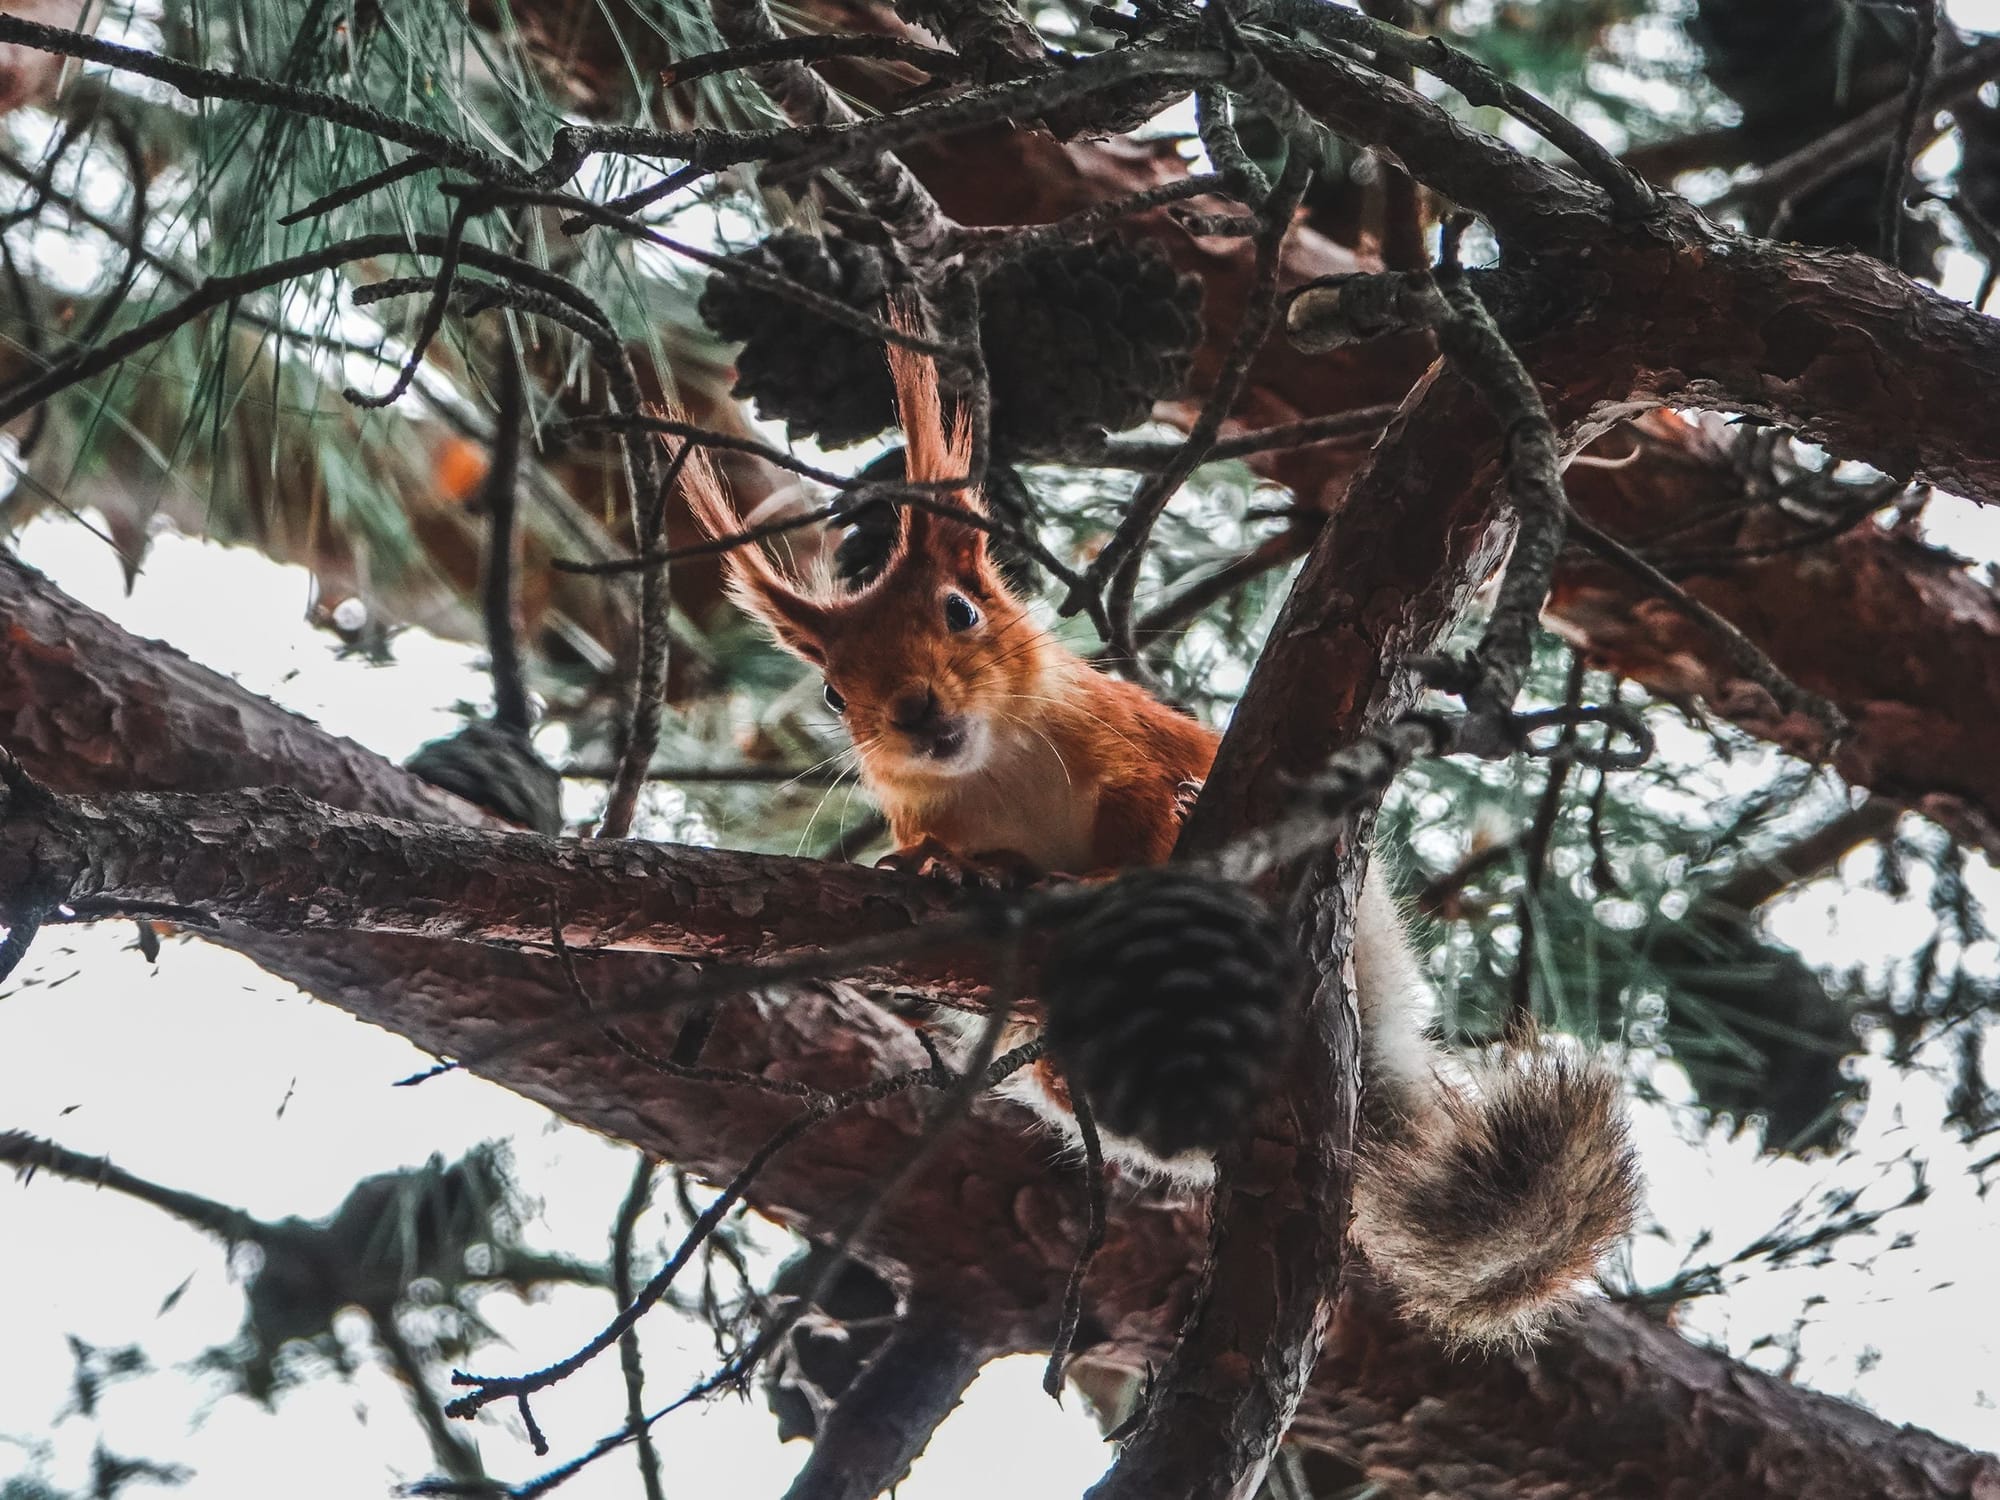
[0,786,992,986]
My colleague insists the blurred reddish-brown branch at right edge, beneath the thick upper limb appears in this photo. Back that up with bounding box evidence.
[1550,432,2000,852]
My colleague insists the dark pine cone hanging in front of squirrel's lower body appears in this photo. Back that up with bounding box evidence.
[1042,870,1298,1158]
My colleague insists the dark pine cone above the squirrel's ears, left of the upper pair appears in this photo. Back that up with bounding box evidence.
[700,230,902,448]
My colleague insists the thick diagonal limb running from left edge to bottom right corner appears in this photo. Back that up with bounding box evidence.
[0,508,2000,1500]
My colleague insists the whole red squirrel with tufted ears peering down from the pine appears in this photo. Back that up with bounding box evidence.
[684,334,1636,1344]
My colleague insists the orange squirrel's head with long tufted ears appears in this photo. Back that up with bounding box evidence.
[684,320,1060,790]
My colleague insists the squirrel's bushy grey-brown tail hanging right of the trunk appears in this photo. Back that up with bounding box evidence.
[1354,880,1640,1346]
